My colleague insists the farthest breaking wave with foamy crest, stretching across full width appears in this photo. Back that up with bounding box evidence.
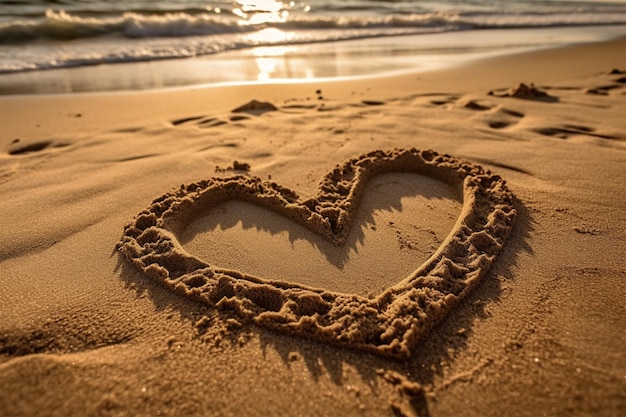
[0,10,626,45]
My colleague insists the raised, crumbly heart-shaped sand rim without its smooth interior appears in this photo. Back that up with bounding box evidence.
[118,149,515,358]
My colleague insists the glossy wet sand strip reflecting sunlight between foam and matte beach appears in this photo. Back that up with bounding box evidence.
[0,25,626,95]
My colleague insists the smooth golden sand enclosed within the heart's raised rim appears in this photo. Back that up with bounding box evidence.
[176,172,462,292]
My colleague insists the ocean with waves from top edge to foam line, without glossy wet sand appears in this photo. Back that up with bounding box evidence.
[0,0,626,92]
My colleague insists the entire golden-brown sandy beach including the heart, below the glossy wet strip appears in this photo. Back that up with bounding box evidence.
[0,36,626,416]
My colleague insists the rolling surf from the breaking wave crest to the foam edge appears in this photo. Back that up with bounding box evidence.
[0,4,626,74]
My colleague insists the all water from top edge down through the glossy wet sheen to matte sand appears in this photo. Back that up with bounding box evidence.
[0,0,626,94]
